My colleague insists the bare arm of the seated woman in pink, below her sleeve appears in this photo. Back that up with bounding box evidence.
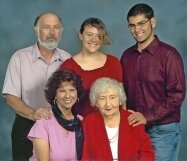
[32,138,49,161]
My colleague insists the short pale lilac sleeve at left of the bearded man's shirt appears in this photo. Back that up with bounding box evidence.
[2,54,21,98]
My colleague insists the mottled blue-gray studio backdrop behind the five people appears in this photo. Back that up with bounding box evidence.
[0,0,187,161]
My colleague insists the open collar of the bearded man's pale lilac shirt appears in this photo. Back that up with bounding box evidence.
[32,43,62,62]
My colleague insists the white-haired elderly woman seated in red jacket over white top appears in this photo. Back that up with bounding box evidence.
[82,78,154,161]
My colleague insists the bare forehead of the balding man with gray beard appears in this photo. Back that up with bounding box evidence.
[39,14,60,25]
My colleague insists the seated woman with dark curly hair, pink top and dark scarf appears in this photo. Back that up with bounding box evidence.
[27,70,83,161]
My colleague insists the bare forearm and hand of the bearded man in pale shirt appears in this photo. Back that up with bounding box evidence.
[6,94,51,121]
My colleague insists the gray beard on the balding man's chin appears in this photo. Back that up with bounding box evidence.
[38,37,60,50]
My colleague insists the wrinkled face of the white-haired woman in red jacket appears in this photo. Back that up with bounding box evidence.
[96,88,120,117]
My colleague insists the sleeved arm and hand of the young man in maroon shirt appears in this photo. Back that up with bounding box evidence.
[129,49,186,126]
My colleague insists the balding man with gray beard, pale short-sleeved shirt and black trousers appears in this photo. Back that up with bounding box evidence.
[2,13,71,161]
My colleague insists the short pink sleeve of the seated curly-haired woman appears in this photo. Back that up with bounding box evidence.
[28,119,48,141]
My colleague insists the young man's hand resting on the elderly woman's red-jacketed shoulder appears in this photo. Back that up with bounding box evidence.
[128,110,147,126]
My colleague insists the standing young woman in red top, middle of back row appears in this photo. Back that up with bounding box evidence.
[61,18,122,116]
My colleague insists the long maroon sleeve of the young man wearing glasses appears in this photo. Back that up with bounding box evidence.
[147,49,186,123]
